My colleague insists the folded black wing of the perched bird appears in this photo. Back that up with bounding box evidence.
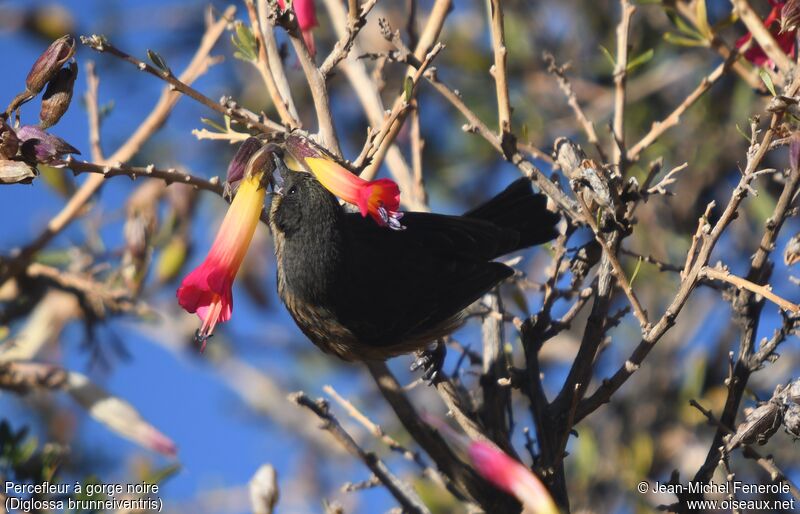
[337,213,518,346]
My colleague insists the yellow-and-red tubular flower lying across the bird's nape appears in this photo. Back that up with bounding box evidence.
[285,134,405,230]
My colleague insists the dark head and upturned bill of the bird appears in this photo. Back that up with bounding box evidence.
[269,153,342,236]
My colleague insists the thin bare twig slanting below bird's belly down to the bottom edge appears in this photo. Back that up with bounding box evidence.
[289,392,430,514]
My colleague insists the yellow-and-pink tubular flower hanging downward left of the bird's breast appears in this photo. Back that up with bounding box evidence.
[177,173,266,351]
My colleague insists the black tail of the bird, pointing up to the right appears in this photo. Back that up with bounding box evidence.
[464,178,561,251]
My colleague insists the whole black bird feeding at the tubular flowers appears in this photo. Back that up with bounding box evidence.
[269,156,560,361]
